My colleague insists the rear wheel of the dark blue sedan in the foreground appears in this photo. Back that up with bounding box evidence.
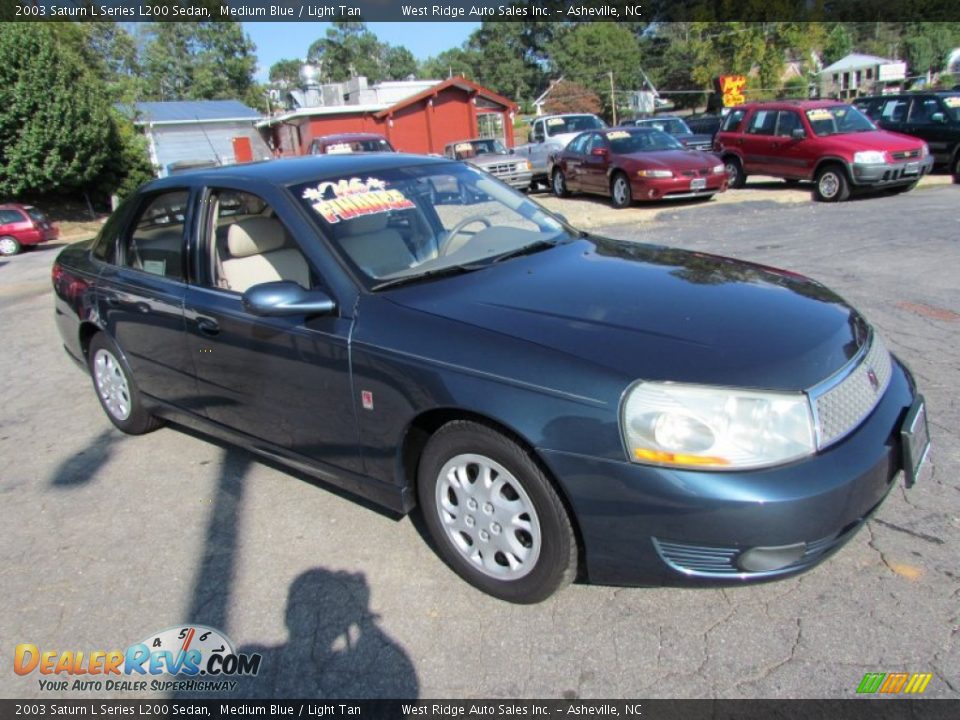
[87,332,162,435]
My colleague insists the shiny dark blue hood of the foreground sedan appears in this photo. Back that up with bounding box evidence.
[390,238,868,390]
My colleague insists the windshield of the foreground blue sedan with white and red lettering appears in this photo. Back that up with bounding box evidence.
[290,162,573,289]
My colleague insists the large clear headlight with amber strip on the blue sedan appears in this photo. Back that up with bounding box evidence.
[621,382,816,470]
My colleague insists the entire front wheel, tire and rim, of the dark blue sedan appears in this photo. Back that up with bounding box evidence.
[417,420,577,604]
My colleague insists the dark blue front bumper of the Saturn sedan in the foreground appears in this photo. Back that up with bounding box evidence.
[540,362,915,585]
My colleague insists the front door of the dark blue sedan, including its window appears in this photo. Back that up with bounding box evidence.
[185,188,361,471]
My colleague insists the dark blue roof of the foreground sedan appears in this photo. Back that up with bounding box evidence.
[146,153,452,190]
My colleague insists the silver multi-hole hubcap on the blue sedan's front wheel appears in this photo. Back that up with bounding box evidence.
[436,455,541,580]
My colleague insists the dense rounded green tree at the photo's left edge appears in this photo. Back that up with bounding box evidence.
[0,23,114,196]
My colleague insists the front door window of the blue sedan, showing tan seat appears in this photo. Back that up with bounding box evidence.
[204,189,317,293]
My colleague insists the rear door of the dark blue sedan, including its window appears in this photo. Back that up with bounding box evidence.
[97,187,196,407]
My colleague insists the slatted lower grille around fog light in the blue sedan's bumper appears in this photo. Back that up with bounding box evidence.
[652,516,866,577]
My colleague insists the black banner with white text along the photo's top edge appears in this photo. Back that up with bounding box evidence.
[0,0,960,22]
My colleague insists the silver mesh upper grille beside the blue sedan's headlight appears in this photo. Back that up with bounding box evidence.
[810,333,893,449]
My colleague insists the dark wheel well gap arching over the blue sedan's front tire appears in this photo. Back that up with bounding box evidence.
[399,408,586,574]
